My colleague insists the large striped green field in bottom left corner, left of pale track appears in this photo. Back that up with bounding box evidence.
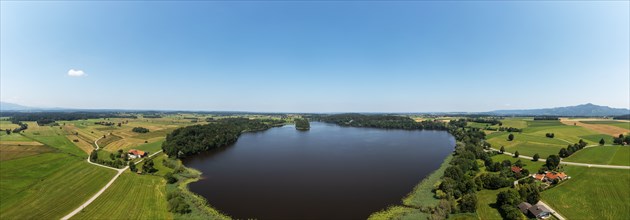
[0,153,115,219]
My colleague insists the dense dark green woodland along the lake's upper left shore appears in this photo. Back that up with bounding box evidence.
[162,118,284,158]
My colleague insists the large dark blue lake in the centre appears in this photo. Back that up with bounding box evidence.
[184,122,455,220]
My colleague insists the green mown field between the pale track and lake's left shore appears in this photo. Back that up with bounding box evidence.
[72,171,173,219]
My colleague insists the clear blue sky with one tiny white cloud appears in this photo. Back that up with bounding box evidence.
[0,1,630,112]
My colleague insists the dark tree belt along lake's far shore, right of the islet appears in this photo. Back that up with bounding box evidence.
[309,114,447,130]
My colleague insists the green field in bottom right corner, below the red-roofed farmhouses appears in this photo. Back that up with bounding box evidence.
[542,166,630,219]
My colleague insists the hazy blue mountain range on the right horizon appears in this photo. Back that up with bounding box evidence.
[488,103,630,117]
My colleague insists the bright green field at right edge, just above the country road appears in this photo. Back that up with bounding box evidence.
[564,146,630,166]
